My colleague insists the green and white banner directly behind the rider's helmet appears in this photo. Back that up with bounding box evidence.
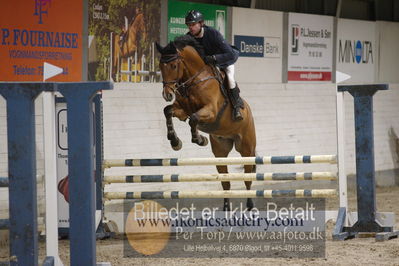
[168,0,227,42]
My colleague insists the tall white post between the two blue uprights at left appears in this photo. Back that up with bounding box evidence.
[43,92,63,265]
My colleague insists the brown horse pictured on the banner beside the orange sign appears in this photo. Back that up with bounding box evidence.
[112,13,147,81]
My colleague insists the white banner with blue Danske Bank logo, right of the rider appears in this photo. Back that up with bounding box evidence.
[232,7,283,83]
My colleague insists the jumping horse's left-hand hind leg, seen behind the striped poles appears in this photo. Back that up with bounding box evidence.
[209,135,233,211]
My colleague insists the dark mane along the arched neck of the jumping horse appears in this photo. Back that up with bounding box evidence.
[161,35,205,63]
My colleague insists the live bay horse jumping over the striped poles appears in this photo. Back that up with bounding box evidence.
[157,35,256,211]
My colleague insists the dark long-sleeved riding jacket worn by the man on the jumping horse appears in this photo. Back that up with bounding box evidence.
[187,25,239,68]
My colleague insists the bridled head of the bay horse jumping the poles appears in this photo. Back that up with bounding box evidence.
[156,42,184,102]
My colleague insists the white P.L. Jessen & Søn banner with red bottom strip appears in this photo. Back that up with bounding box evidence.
[287,13,334,82]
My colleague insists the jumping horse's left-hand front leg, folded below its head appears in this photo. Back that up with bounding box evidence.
[163,104,188,151]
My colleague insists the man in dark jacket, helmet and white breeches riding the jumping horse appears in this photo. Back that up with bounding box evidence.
[185,10,244,121]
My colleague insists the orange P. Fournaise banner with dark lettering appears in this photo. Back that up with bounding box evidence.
[0,0,84,81]
